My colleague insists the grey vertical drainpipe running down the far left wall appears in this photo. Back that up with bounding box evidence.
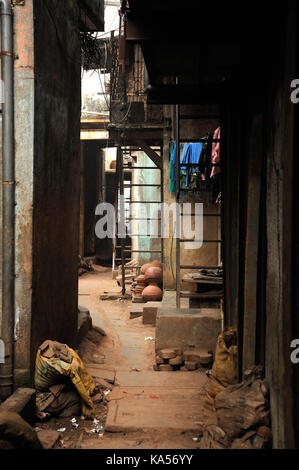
[0,0,15,400]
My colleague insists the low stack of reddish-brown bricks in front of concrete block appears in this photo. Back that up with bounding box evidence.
[153,348,213,371]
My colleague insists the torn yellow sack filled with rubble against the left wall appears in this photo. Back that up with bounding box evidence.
[34,340,95,417]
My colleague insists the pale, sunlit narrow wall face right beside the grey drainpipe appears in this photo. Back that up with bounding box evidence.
[14,1,35,387]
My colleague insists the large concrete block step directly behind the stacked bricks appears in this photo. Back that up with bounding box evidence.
[155,307,221,353]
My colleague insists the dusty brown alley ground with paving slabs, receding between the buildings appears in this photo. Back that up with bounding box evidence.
[42,268,207,449]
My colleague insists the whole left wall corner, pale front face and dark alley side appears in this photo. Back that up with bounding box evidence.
[2,0,80,387]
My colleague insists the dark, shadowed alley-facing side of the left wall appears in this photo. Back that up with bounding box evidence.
[31,0,81,374]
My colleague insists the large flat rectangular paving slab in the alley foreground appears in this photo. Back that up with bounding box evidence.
[105,371,207,432]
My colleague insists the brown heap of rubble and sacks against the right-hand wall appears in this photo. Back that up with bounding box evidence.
[200,328,272,449]
